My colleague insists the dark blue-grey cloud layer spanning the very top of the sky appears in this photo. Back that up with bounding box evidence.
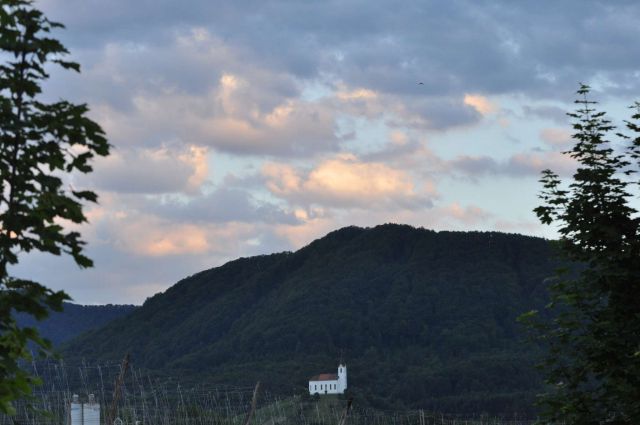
[38,0,640,105]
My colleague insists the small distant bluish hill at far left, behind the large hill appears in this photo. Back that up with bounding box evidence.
[18,303,136,346]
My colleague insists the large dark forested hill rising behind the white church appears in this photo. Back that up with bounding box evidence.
[67,224,557,415]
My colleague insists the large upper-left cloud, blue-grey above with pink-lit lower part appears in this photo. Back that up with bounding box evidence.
[47,27,339,156]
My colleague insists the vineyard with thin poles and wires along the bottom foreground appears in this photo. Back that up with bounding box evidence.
[0,362,535,425]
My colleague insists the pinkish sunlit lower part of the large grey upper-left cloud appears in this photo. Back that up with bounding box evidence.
[87,66,339,156]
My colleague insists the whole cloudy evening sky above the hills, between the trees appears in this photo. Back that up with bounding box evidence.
[14,0,640,304]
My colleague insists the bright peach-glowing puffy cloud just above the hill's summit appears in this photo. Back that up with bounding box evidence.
[262,154,435,208]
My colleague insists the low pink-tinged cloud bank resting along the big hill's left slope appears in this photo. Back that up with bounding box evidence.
[12,217,292,304]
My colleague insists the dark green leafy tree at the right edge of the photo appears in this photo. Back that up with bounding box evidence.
[535,85,640,424]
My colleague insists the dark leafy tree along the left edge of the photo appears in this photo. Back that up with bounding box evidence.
[0,0,109,413]
